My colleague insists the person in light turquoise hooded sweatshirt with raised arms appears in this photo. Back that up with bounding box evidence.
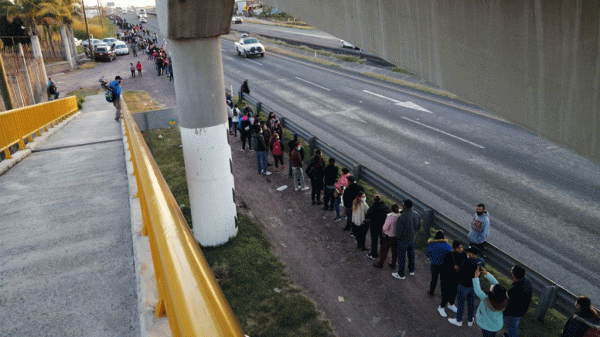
[473,267,508,337]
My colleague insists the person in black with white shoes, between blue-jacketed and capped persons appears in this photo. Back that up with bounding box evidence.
[438,240,467,317]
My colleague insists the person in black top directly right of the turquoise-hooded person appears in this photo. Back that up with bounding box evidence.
[504,264,532,337]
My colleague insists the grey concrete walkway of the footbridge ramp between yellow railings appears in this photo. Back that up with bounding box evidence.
[0,95,140,336]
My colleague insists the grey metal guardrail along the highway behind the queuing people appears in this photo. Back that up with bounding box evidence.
[236,90,577,320]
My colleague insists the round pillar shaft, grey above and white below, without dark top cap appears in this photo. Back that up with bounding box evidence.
[170,37,237,246]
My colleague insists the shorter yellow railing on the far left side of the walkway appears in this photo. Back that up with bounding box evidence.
[0,96,78,159]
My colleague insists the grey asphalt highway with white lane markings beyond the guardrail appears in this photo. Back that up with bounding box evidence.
[119,12,600,303]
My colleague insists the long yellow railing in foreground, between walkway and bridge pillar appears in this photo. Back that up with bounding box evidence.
[123,109,244,337]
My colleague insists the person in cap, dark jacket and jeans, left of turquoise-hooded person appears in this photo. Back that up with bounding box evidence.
[448,247,485,326]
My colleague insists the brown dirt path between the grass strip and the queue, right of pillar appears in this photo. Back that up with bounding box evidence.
[230,136,481,337]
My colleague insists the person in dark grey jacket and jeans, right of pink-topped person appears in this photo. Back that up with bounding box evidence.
[392,199,421,280]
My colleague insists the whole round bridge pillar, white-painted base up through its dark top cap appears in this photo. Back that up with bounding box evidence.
[156,0,237,246]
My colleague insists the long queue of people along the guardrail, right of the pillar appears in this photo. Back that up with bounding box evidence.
[226,80,600,337]
